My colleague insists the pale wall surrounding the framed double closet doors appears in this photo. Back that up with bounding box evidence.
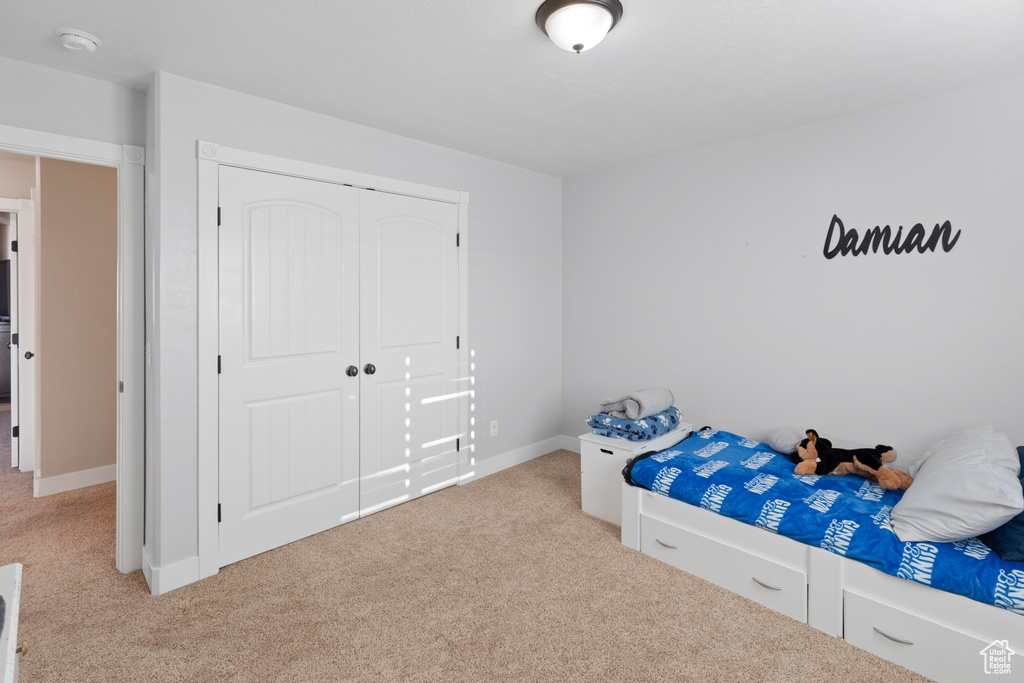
[146,74,562,566]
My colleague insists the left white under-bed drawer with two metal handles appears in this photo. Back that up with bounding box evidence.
[640,515,807,623]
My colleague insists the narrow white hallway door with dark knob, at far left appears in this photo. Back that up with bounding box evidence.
[10,211,36,472]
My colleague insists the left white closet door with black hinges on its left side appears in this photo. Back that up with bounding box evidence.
[219,167,359,566]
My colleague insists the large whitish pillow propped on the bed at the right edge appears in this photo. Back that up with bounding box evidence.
[891,425,1024,543]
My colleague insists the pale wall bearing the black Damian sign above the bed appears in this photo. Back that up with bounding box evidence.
[562,74,1024,453]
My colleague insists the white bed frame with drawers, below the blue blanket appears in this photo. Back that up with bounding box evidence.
[622,483,1024,683]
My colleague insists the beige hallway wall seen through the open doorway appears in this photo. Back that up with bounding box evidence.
[37,159,118,477]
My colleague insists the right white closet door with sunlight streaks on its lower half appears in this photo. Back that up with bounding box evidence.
[359,191,460,515]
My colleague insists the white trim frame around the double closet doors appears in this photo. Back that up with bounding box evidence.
[196,140,468,579]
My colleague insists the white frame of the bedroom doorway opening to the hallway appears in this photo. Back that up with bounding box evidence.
[0,125,145,573]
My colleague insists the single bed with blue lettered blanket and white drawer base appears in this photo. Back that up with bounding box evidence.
[622,430,1024,681]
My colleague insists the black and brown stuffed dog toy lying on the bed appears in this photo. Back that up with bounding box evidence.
[796,429,913,490]
